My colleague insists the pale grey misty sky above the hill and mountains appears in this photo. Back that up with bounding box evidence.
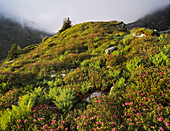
[0,0,170,32]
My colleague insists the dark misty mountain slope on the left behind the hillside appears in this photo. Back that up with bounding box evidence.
[0,16,49,60]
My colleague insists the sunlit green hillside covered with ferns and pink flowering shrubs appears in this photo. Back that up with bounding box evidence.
[0,21,170,131]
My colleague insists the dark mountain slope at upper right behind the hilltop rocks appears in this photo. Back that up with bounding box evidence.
[127,5,170,31]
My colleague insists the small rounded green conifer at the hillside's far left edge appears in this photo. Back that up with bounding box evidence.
[7,44,21,60]
